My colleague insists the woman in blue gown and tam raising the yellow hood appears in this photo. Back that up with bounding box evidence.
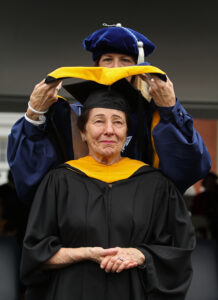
[8,24,211,203]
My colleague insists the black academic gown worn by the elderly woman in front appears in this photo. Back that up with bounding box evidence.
[21,161,195,300]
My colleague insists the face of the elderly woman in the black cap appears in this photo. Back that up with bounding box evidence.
[82,108,127,158]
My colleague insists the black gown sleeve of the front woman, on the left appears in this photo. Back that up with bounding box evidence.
[21,172,64,285]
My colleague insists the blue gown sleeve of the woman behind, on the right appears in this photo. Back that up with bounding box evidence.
[152,100,211,193]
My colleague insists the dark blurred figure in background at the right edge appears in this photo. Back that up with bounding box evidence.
[191,172,218,240]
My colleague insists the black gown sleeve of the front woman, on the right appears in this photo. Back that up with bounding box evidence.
[137,182,195,300]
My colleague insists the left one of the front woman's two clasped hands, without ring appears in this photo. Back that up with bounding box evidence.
[87,247,118,264]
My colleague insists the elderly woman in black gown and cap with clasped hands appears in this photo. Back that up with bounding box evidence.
[21,79,195,300]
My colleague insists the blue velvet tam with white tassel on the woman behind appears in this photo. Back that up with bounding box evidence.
[83,23,155,63]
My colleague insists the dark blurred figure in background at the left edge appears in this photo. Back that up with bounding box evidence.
[0,171,29,246]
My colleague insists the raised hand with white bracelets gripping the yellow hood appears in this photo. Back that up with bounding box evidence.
[27,79,62,120]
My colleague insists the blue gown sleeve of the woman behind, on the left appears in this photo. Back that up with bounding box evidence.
[7,117,57,204]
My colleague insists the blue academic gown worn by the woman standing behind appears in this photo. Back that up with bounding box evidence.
[8,99,211,203]
